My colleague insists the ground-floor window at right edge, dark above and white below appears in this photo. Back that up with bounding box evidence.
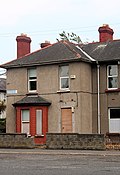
[109,108,120,133]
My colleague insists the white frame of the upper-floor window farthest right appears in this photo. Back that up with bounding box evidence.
[107,64,118,90]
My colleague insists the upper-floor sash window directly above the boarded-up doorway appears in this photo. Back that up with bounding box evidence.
[59,65,70,90]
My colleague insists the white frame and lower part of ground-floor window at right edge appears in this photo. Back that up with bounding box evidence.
[108,108,120,133]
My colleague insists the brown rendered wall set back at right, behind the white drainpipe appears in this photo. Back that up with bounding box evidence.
[92,63,120,134]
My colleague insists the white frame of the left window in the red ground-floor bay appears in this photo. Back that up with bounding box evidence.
[21,109,30,135]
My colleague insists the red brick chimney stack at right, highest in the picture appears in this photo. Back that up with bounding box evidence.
[98,24,114,42]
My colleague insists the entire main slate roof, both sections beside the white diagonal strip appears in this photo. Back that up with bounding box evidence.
[0,40,120,69]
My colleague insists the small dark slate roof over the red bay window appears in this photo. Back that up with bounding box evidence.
[13,96,51,107]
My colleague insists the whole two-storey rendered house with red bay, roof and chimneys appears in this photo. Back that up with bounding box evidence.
[1,25,120,144]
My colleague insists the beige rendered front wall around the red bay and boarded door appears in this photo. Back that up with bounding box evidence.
[7,62,92,133]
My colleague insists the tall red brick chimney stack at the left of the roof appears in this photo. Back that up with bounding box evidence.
[16,34,31,58]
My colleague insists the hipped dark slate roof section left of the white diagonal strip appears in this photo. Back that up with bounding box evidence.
[1,41,94,68]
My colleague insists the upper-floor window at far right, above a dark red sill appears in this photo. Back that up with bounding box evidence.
[107,65,118,89]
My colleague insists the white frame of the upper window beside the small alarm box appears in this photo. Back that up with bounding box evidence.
[59,65,70,91]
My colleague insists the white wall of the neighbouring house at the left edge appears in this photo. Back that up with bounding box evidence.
[0,78,6,119]
